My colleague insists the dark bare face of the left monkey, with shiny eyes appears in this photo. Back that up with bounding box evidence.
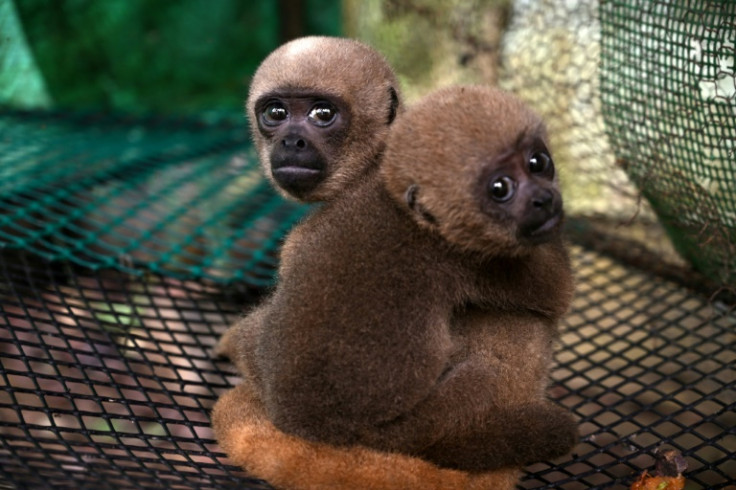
[255,90,350,199]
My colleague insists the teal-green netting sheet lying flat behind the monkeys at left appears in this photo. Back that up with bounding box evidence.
[0,112,305,287]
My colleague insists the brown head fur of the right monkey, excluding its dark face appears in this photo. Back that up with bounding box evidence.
[381,86,556,256]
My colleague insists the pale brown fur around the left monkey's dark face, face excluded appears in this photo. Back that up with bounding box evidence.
[246,36,402,202]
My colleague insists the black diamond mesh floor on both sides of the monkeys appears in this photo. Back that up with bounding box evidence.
[0,242,736,489]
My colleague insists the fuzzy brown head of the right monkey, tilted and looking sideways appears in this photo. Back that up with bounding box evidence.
[381,86,563,256]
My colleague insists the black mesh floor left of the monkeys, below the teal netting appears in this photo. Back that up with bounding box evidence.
[0,253,259,488]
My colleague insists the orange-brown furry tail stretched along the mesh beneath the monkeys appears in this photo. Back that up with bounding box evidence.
[212,383,520,490]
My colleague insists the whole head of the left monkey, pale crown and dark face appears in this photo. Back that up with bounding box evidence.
[246,37,400,201]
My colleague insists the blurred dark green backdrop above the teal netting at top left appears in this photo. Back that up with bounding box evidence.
[0,0,342,114]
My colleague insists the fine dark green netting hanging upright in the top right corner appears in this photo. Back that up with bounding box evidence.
[600,0,736,284]
